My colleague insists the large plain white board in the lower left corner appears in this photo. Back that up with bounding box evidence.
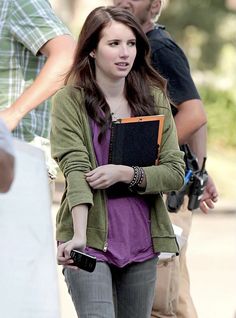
[0,140,60,318]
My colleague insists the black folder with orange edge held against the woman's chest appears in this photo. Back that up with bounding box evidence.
[107,115,164,195]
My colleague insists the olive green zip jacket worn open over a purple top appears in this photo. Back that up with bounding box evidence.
[51,86,184,253]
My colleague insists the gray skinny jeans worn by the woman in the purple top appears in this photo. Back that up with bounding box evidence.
[63,257,158,318]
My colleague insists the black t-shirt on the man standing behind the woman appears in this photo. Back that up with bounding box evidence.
[146,24,200,114]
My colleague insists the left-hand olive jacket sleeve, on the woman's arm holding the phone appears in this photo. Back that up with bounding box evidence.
[50,89,93,210]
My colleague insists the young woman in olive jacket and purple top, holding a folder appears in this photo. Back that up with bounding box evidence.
[51,7,184,318]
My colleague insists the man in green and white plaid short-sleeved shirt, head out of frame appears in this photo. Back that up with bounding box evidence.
[0,0,75,183]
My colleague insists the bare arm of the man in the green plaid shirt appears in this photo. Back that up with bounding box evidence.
[0,35,76,130]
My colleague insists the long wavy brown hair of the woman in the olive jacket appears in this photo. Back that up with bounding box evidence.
[66,6,166,136]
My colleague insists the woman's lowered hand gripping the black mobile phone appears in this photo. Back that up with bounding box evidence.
[57,237,86,268]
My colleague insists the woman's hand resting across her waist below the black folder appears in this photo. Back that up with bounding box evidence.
[85,164,134,189]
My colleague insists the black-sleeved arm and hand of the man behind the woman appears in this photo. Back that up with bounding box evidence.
[152,31,218,213]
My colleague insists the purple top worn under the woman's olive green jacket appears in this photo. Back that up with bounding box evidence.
[85,121,156,267]
